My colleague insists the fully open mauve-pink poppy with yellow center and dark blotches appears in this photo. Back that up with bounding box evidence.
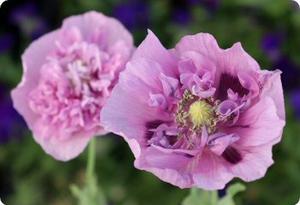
[101,31,285,190]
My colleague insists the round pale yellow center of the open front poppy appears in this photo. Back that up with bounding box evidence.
[189,100,214,128]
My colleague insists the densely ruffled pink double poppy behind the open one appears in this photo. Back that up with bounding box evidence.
[12,12,133,160]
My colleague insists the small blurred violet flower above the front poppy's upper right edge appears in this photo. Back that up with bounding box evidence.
[261,33,284,60]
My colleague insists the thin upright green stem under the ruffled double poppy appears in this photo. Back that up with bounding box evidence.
[86,138,96,181]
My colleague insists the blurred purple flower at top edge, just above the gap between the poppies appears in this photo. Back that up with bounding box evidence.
[113,0,149,29]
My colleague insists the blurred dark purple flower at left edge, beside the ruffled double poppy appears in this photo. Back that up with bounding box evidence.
[0,87,25,144]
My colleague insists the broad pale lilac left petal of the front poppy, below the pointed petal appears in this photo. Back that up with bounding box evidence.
[101,59,169,143]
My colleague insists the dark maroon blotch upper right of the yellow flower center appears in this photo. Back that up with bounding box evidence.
[217,73,249,100]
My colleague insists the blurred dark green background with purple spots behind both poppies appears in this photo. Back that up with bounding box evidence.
[0,0,300,205]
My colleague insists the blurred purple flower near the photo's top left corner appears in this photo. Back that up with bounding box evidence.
[10,3,48,39]
